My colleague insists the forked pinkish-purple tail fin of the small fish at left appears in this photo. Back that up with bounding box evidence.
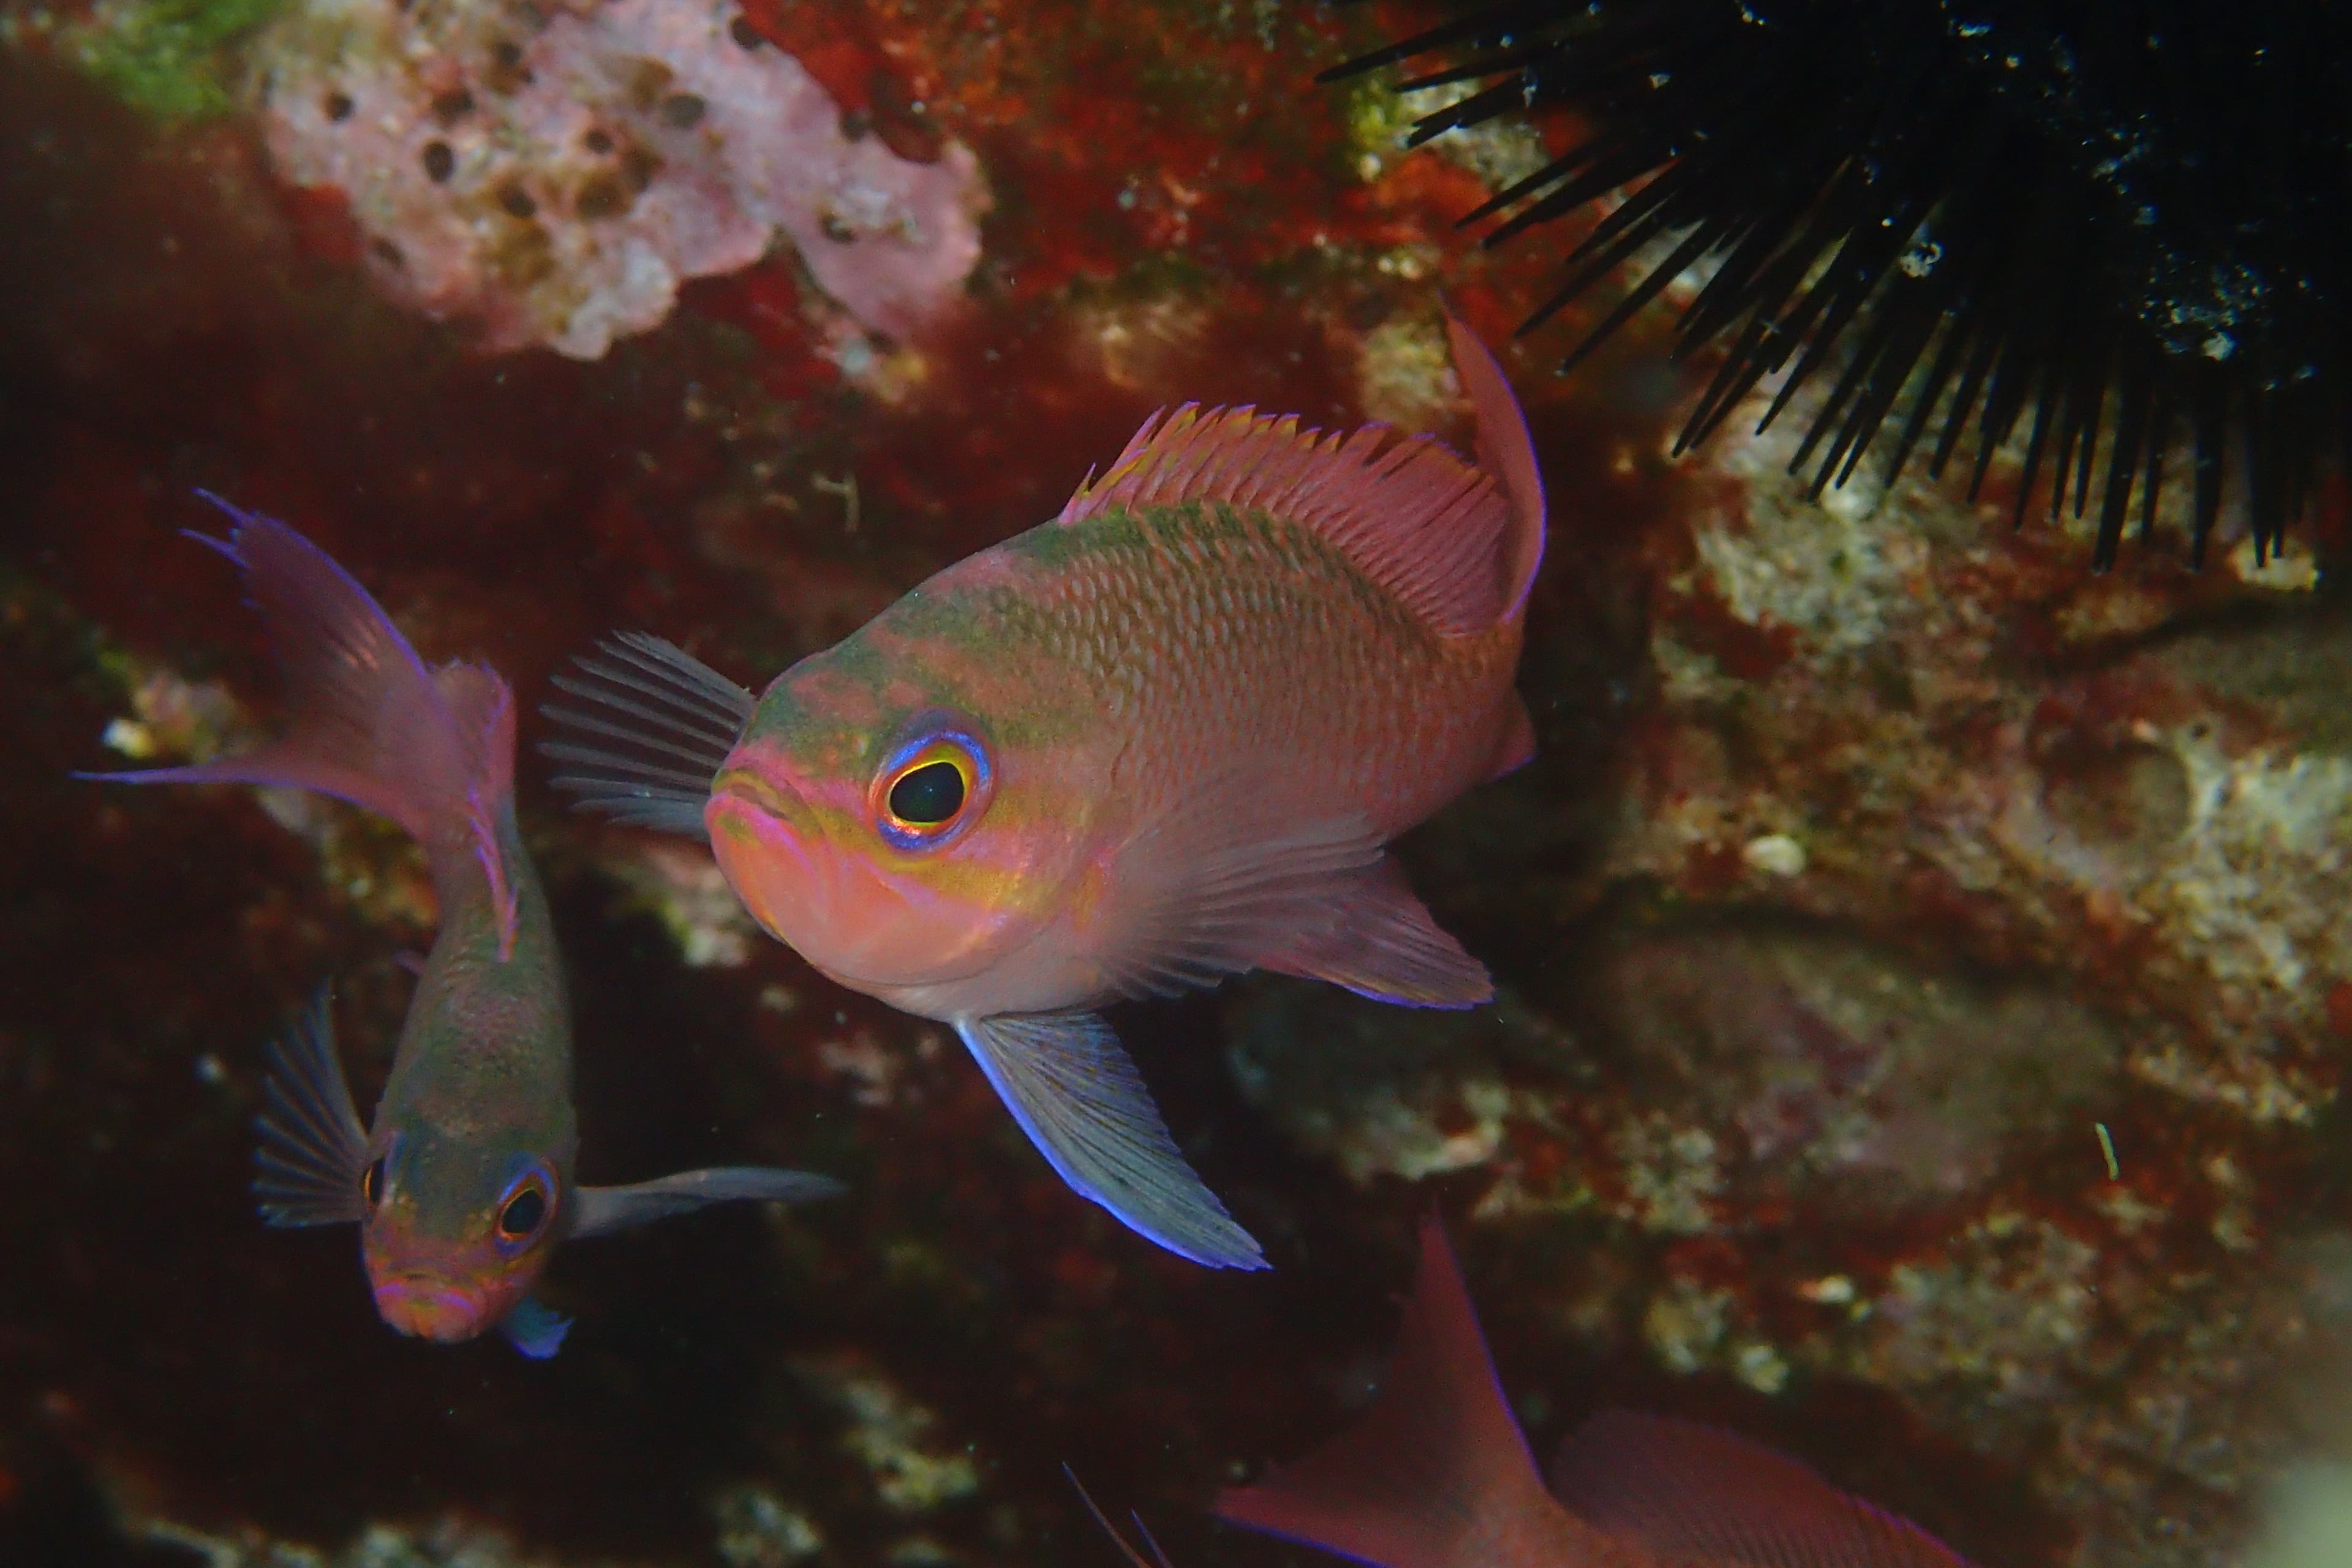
[85,494,515,948]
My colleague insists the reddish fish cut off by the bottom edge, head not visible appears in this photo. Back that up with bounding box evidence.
[1223,1218,1966,1568]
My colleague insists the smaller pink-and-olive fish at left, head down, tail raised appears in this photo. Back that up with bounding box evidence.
[85,496,840,1357]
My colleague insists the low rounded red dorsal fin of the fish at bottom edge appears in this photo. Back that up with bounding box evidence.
[1552,1411,1969,1568]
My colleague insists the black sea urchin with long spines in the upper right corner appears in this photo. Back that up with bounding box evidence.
[1324,0,2352,567]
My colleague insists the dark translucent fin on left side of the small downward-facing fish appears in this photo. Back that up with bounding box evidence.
[254,985,367,1227]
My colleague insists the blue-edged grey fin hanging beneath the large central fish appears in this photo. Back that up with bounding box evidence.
[955,1013,1265,1270]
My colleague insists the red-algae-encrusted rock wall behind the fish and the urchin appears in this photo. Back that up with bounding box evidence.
[23,0,2352,1568]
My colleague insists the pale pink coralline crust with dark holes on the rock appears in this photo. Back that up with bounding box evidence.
[257,0,986,360]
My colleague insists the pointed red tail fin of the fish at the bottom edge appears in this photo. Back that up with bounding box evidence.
[1216,1215,1574,1568]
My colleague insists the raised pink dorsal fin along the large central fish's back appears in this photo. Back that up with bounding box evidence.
[1058,317,1543,637]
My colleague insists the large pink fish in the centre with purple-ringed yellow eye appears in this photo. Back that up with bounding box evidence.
[546,322,1543,1267]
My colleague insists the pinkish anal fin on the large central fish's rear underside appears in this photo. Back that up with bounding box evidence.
[1265,856,1493,1009]
